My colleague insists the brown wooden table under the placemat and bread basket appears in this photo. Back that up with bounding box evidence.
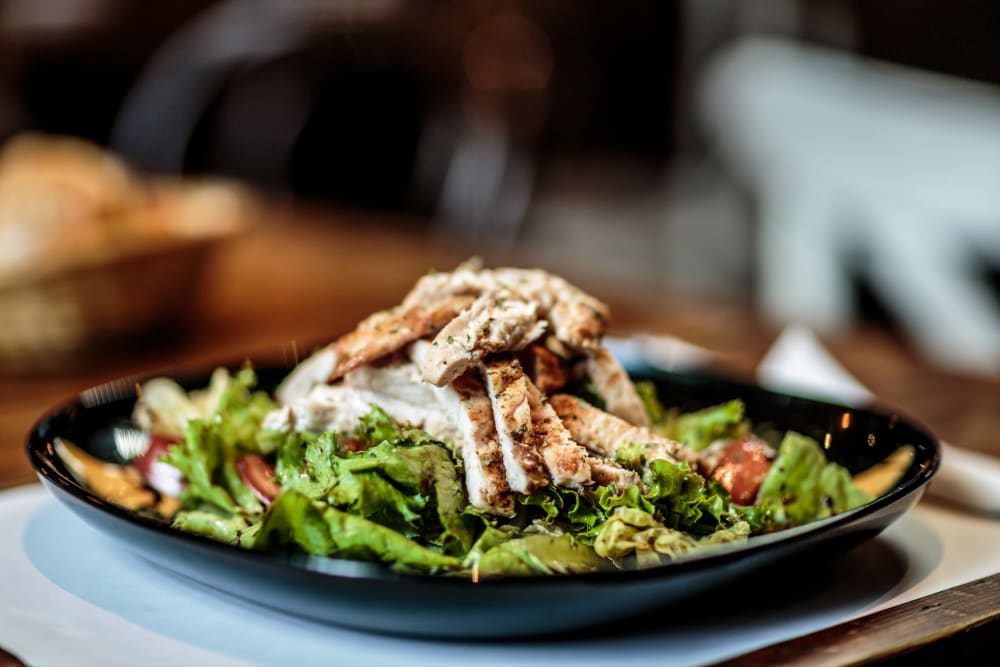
[0,207,1000,664]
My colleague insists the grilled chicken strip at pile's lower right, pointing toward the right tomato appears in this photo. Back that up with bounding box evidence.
[549,394,705,471]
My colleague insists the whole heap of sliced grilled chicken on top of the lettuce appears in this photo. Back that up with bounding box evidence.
[272,263,699,516]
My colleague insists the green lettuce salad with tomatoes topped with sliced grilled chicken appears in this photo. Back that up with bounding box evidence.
[60,262,892,579]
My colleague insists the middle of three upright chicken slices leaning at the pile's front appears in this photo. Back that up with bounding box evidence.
[484,359,549,494]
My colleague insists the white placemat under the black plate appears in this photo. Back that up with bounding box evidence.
[0,480,1000,667]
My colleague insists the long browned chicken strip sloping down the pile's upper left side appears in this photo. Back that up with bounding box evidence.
[329,296,473,382]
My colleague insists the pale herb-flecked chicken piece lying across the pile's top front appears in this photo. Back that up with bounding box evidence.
[420,290,546,387]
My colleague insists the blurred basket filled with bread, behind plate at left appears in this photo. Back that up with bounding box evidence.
[0,130,250,371]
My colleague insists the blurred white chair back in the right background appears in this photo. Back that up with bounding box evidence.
[700,38,1000,374]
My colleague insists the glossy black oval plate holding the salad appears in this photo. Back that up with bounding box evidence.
[27,367,940,638]
